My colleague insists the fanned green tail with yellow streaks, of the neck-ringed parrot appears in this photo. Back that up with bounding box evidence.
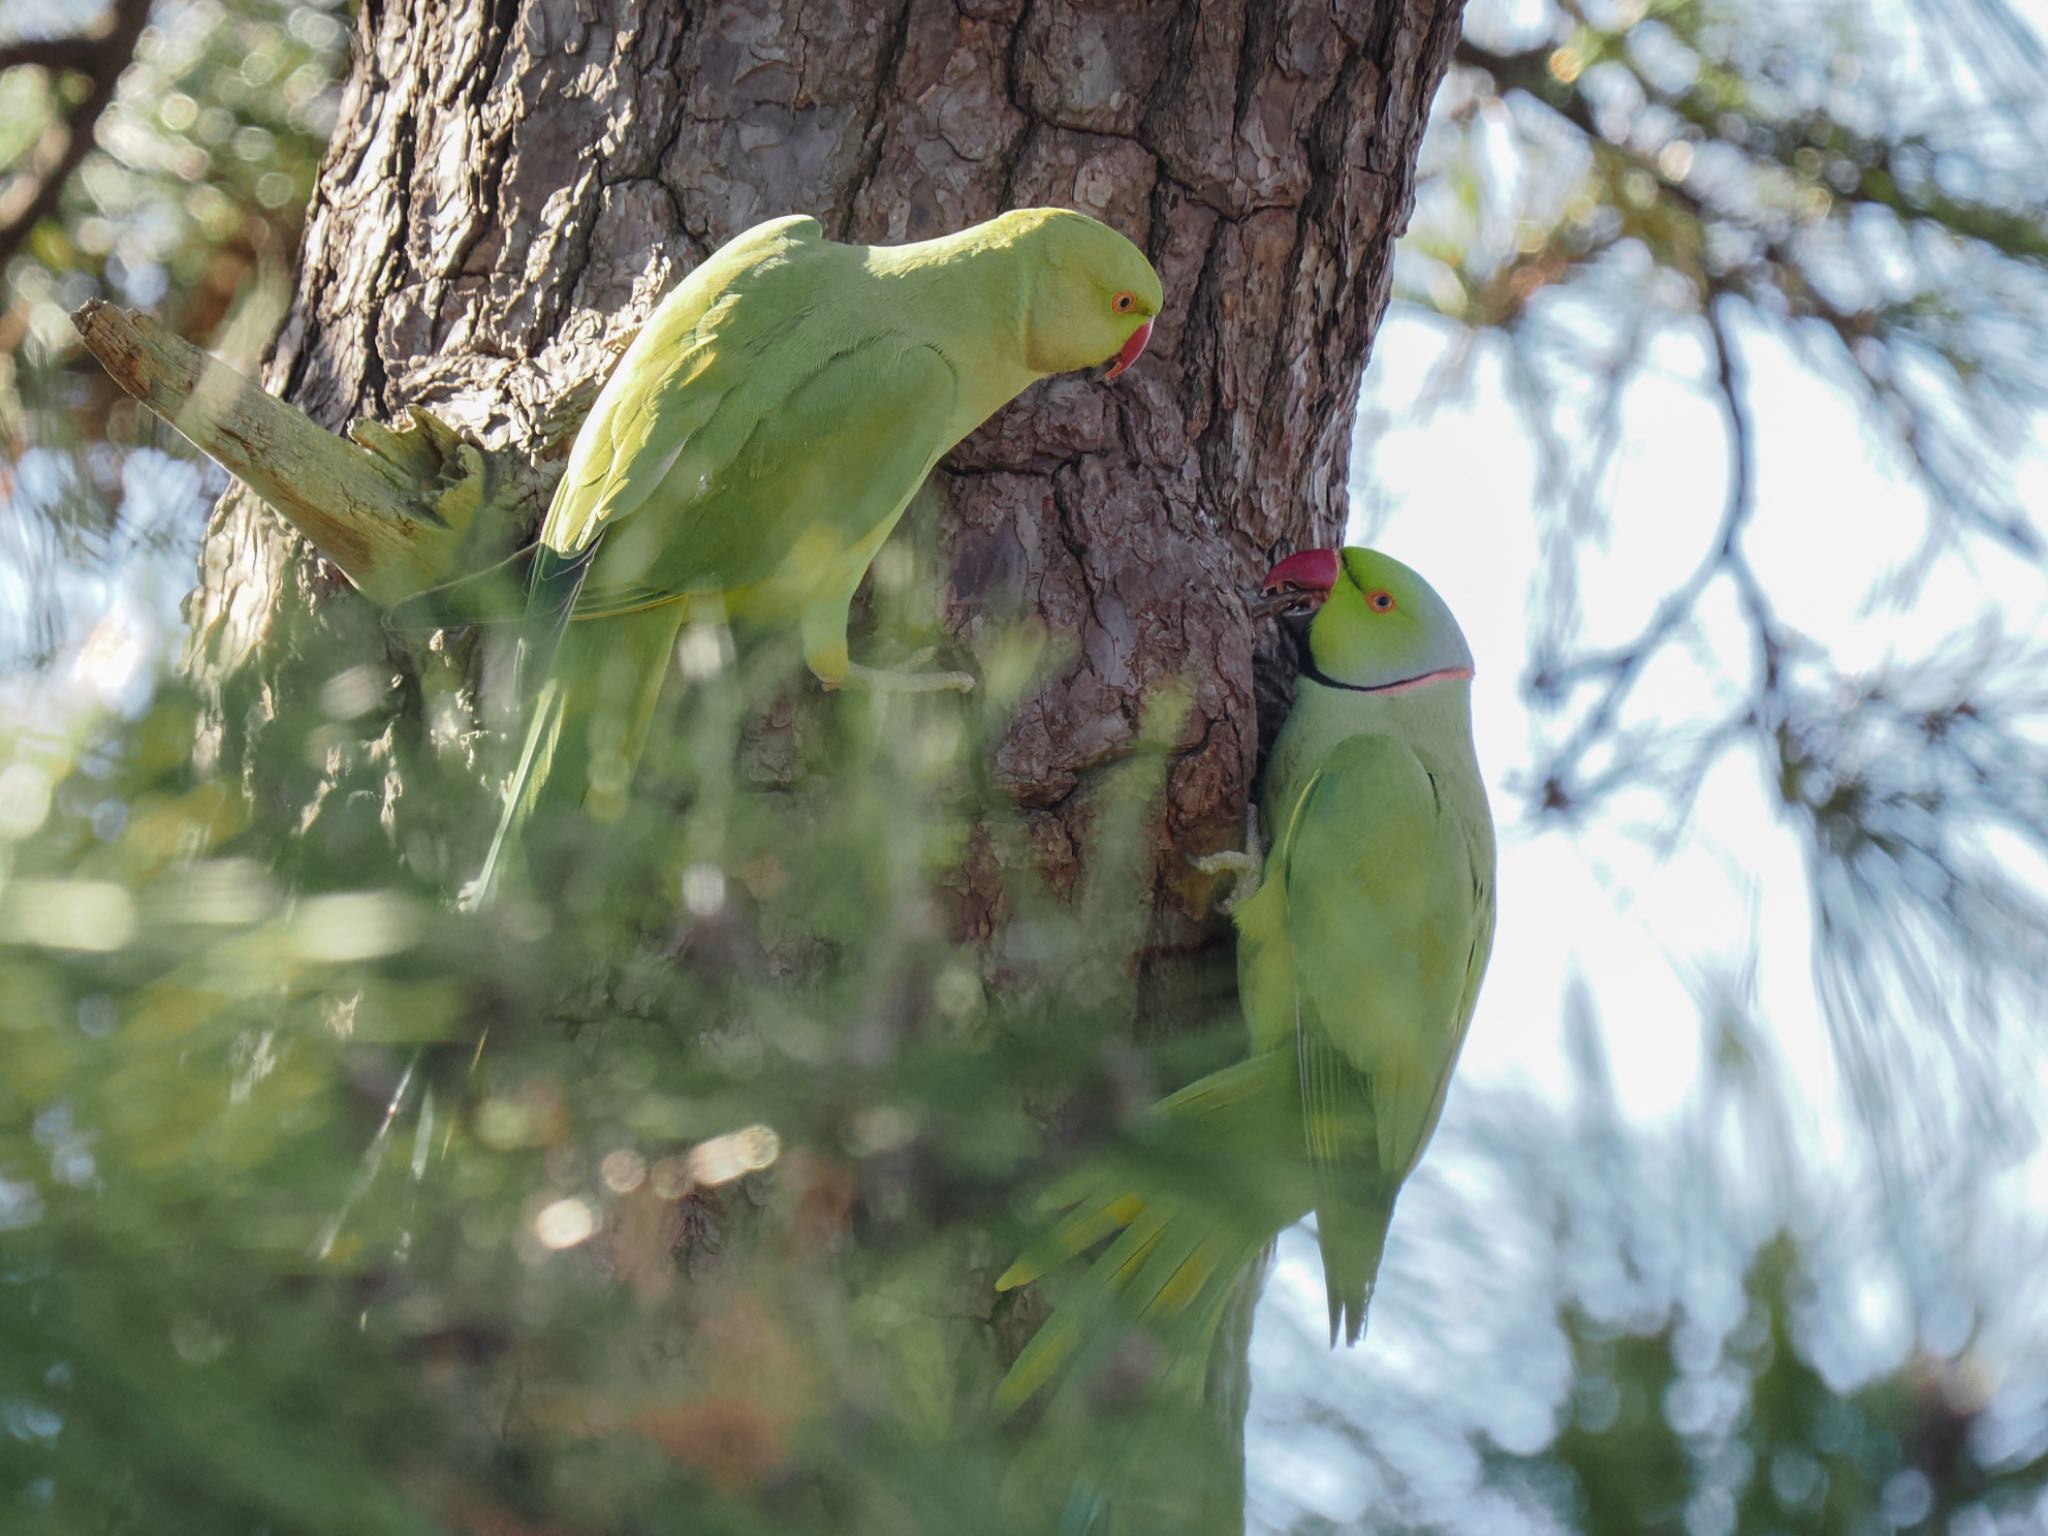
[995,1044,1393,1536]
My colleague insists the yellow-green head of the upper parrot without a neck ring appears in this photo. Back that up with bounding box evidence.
[1010,209,1161,379]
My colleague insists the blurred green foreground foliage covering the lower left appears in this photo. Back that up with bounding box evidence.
[0,559,1237,1532]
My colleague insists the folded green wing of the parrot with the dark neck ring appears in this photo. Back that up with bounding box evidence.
[1280,735,1493,1341]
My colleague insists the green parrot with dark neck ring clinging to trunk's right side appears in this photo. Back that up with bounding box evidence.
[997,549,1493,1403]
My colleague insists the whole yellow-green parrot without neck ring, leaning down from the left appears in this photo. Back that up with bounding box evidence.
[471,209,1161,897]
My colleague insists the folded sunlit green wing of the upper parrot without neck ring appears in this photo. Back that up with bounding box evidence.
[541,219,958,618]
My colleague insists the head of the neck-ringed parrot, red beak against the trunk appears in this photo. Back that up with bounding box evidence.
[1262,545,1473,692]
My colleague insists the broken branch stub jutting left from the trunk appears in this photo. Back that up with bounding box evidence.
[72,299,516,608]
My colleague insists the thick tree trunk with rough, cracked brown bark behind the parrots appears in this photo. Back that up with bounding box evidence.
[176,0,1460,1531]
